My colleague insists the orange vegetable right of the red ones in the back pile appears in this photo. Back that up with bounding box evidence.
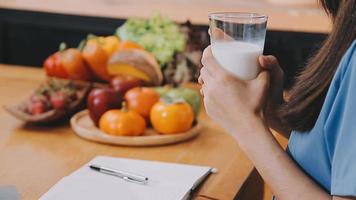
[82,42,111,81]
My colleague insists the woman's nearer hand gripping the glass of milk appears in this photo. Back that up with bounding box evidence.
[199,46,270,133]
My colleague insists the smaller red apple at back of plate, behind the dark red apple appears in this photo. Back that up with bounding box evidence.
[110,75,144,95]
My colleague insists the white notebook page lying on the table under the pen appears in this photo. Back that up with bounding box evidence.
[40,156,216,200]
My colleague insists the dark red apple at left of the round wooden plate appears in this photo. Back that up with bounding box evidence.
[88,88,123,126]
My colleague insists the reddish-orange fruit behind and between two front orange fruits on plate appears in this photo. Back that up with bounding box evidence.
[125,87,160,120]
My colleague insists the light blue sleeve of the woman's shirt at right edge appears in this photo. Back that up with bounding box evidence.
[324,42,356,197]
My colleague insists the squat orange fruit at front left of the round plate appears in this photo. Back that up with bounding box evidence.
[99,109,146,136]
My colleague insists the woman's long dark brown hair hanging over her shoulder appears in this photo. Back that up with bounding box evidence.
[279,0,356,132]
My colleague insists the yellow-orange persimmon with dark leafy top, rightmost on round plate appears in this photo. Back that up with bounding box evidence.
[150,101,194,134]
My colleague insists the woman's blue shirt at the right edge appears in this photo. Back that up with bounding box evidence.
[288,40,356,196]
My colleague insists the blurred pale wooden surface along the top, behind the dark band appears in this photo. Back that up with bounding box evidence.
[0,0,331,33]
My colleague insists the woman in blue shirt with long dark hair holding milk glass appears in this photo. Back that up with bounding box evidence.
[199,0,356,200]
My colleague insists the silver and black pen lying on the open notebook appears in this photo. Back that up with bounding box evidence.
[89,165,148,184]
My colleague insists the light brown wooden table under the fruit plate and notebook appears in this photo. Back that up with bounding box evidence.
[0,64,253,200]
